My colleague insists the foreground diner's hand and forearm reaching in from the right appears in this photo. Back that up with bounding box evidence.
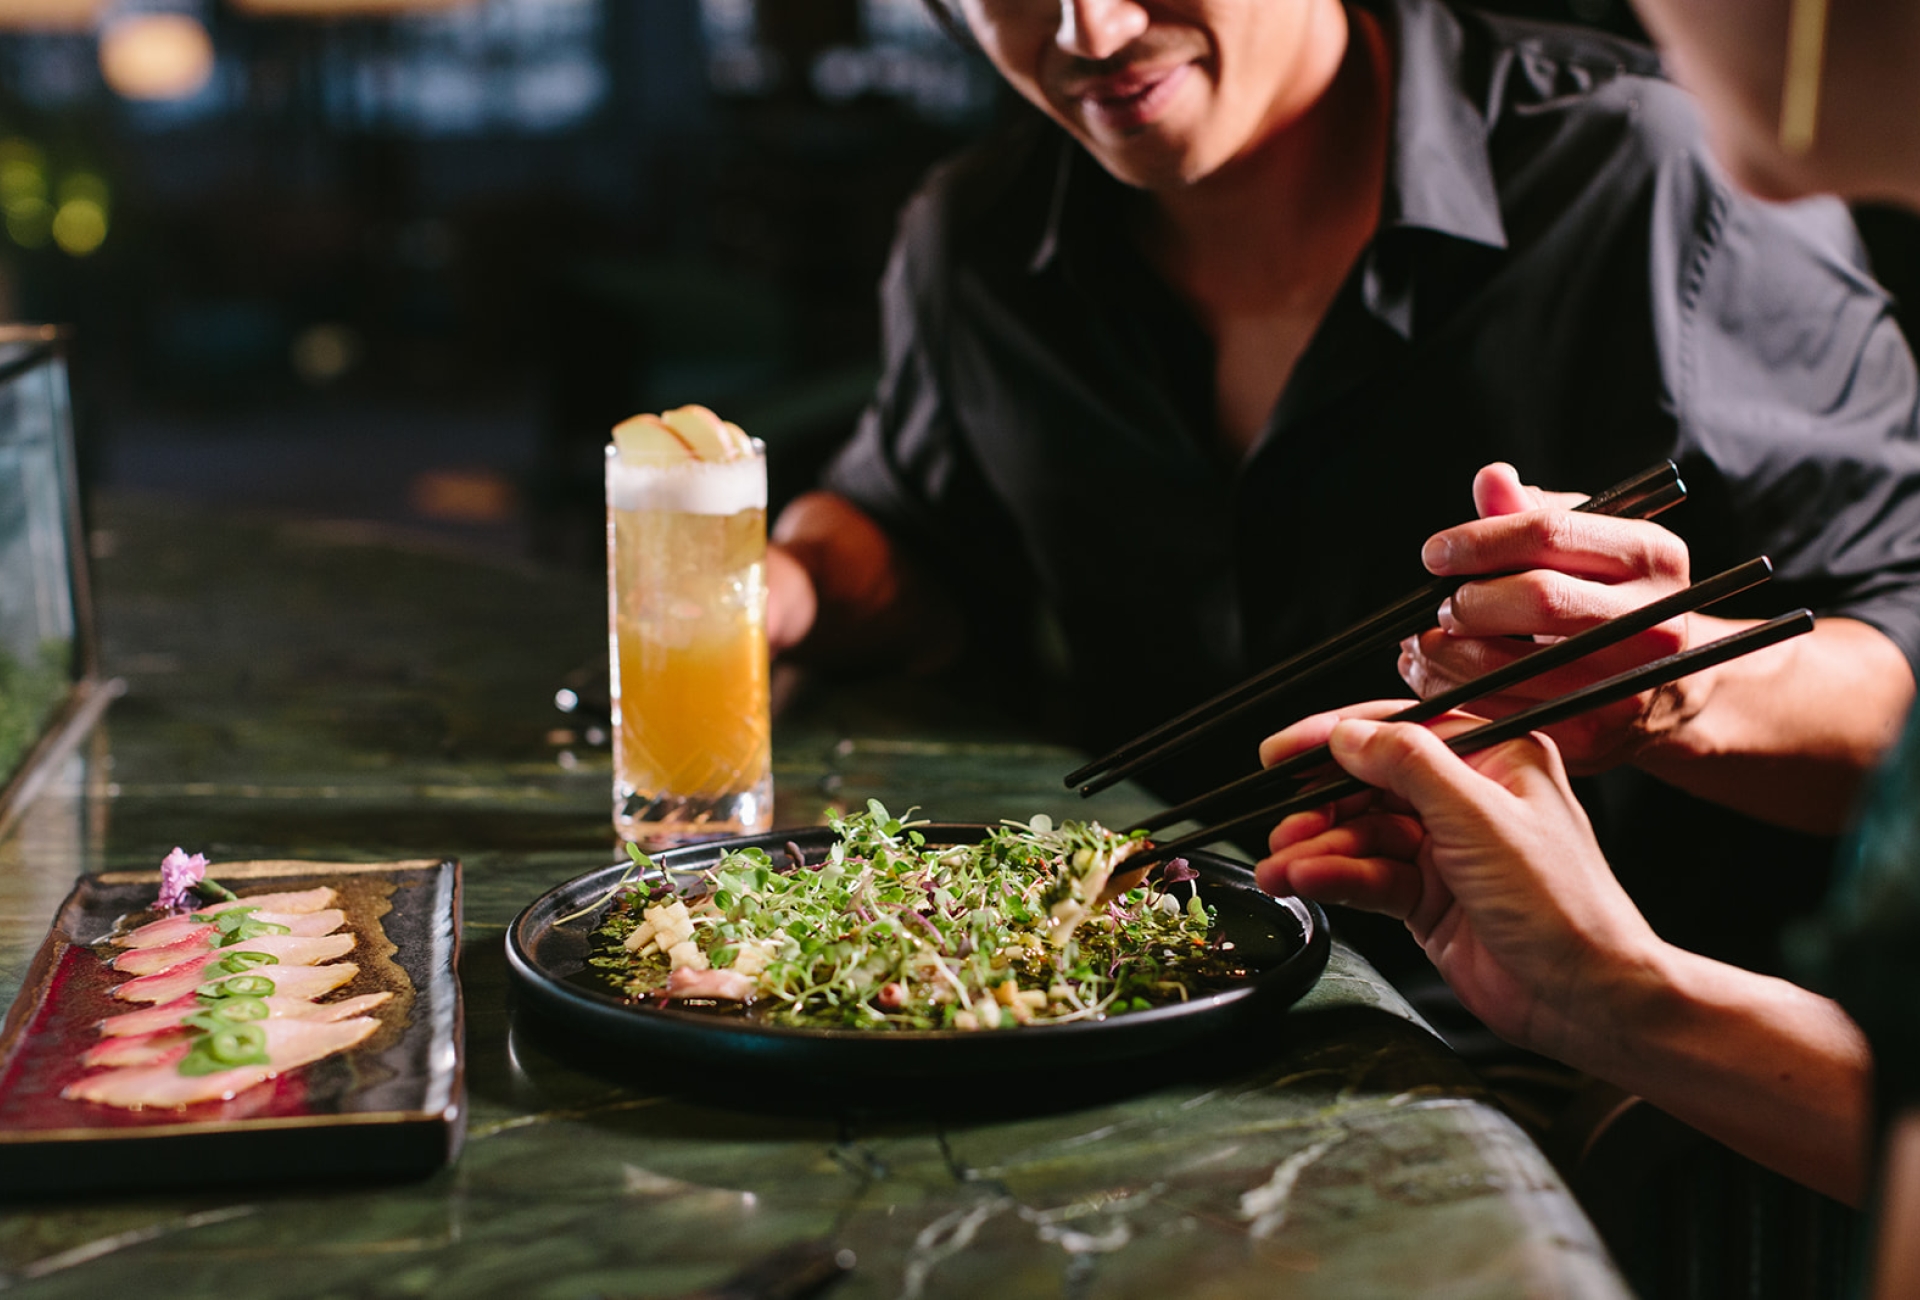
[1258,701,1870,1204]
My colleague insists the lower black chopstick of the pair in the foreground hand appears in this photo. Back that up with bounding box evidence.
[1127,609,1812,868]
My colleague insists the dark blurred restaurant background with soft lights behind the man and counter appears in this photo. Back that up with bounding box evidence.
[0,0,1920,568]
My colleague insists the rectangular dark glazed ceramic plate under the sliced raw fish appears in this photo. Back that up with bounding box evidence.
[0,860,467,1194]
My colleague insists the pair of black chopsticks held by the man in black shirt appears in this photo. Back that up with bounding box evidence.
[1066,461,1686,797]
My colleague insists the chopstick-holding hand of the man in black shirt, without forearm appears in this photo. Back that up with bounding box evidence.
[1400,465,1711,772]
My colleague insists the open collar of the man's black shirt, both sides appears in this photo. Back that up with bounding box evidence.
[1027,0,1507,275]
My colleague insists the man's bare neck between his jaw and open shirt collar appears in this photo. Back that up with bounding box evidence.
[1140,4,1392,309]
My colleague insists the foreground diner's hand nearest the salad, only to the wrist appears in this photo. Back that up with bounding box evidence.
[1258,701,1665,1060]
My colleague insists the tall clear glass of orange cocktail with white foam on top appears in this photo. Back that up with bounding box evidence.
[607,442,774,847]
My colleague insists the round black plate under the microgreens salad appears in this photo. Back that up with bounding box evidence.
[507,824,1329,1083]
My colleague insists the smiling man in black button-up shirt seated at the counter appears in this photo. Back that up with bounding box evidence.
[770,0,1920,968]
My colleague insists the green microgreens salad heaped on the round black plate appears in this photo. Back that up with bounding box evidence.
[589,801,1246,1029]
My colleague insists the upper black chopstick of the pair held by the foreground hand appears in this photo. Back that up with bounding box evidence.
[1129,555,1774,831]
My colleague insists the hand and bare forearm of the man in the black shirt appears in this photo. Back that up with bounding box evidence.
[1400,465,1914,833]
